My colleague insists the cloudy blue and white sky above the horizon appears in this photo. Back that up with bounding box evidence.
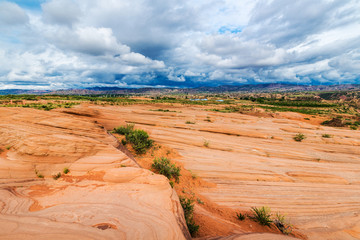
[0,0,360,90]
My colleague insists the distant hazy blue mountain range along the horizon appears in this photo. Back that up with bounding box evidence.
[0,83,360,95]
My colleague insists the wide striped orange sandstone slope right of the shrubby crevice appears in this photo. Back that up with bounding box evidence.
[88,105,360,240]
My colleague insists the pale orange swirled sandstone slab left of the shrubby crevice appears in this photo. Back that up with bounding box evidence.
[0,108,189,240]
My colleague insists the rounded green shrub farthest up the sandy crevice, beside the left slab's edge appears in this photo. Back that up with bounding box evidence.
[125,130,153,154]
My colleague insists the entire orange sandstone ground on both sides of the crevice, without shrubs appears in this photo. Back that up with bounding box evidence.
[0,103,360,240]
